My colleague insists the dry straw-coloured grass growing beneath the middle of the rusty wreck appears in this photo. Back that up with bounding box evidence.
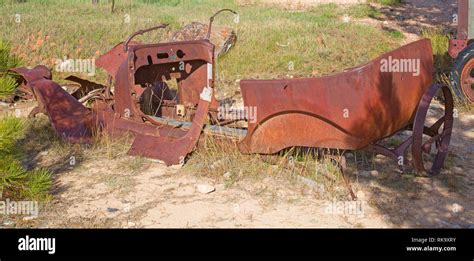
[184,136,349,199]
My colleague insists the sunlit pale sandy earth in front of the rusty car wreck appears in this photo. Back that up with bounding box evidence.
[39,157,389,227]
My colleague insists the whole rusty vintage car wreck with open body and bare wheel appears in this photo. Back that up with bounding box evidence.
[12,10,453,174]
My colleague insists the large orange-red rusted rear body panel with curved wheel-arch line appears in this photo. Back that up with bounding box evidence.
[239,39,433,154]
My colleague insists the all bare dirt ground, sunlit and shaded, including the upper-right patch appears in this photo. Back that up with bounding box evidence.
[4,1,474,228]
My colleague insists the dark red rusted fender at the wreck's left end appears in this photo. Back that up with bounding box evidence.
[12,66,95,143]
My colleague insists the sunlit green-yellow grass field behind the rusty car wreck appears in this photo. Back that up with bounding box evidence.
[0,0,400,95]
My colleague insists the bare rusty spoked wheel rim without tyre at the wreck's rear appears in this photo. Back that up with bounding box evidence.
[412,84,454,175]
